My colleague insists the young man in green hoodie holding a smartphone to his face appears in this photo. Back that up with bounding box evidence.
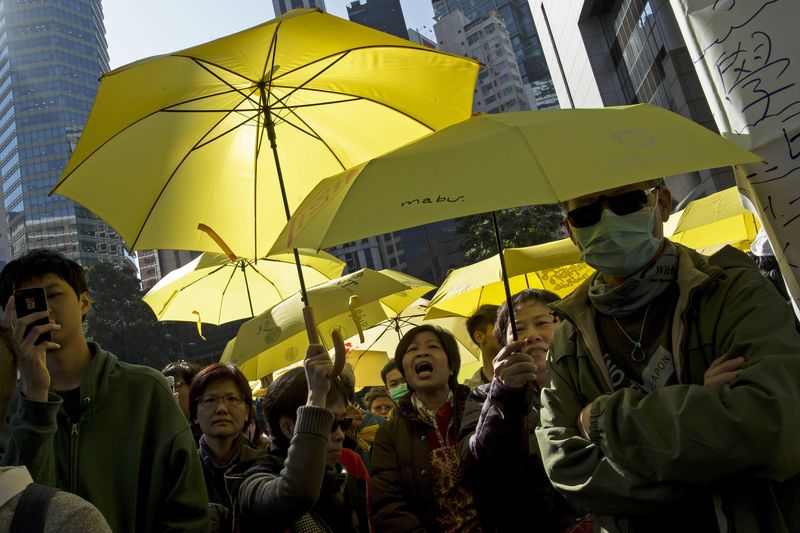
[0,250,209,532]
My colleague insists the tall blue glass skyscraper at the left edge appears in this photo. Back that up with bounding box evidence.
[0,0,127,265]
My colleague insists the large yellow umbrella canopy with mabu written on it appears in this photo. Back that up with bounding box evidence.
[272,104,759,252]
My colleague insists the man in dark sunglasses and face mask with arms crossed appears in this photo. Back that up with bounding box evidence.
[536,180,800,532]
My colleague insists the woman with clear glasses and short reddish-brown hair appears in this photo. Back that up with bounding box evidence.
[189,363,259,532]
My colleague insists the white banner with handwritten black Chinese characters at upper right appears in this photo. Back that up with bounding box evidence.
[670,0,800,309]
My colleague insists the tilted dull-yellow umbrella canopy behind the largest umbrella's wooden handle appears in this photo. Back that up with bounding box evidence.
[225,268,433,379]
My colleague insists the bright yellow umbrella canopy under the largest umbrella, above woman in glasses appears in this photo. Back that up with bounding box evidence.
[142,250,345,324]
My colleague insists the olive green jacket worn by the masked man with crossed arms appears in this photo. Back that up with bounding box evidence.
[536,245,800,532]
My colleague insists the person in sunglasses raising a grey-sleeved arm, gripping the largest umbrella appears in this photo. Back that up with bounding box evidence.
[227,345,371,532]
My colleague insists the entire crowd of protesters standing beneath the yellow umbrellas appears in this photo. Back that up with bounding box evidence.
[0,180,800,533]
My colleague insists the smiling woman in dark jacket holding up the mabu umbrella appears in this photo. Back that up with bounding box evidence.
[459,289,591,533]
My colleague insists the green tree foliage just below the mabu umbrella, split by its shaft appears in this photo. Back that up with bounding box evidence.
[457,205,566,264]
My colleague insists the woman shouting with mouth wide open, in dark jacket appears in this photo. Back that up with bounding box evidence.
[371,325,480,532]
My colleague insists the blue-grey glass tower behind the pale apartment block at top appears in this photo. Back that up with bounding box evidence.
[431,0,558,109]
